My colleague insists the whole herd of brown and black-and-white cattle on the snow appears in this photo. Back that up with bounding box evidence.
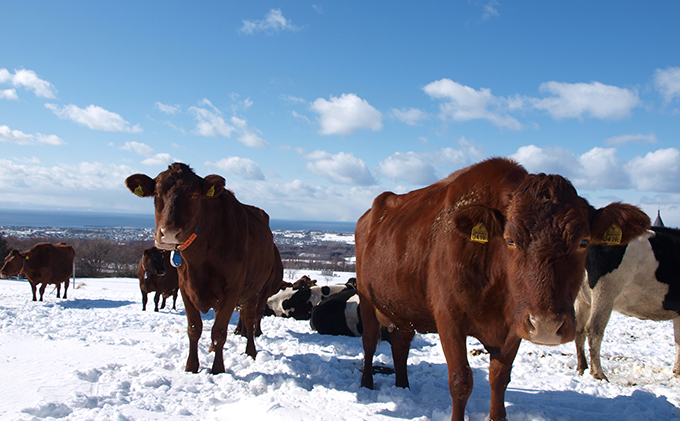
[0,158,680,420]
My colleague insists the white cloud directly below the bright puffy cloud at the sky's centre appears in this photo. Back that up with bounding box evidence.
[305,151,375,186]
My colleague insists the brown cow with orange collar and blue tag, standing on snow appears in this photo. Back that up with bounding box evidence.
[125,163,283,374]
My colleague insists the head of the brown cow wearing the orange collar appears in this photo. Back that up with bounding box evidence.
[125,162,225,250]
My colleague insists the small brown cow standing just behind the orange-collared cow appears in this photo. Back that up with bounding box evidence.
[137,247,179,311]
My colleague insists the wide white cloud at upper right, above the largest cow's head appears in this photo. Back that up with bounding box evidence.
[533,81,640,120]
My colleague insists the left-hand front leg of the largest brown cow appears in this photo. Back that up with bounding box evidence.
[437,320,474,421]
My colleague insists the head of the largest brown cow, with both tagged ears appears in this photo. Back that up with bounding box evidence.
[454,174,649,345]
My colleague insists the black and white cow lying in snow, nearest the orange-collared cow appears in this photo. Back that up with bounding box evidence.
[264,284,352,320]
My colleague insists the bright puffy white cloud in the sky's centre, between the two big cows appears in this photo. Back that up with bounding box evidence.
[311,94,382,136]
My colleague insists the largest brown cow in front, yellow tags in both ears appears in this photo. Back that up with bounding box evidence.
[356,158,649,420]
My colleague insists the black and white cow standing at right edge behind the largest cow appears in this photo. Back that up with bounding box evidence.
[575,227,680,380]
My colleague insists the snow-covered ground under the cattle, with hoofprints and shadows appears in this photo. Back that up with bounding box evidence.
[0,271,680,421]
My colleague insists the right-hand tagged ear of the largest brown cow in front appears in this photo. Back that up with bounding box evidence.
[590,202,649,245]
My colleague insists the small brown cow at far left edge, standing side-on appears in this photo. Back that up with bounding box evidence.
[0,243,76,301]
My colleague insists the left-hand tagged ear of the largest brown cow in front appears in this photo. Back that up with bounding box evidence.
[453,205,505,243]
